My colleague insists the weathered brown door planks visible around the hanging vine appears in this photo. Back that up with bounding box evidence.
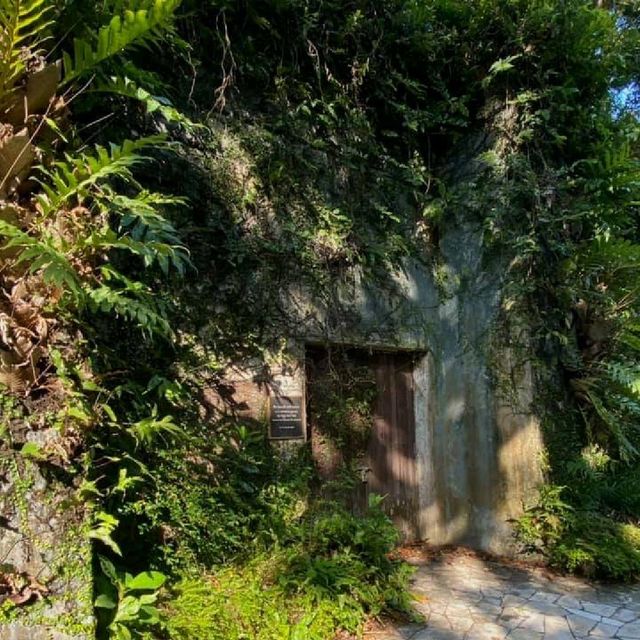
[307,349,418,541]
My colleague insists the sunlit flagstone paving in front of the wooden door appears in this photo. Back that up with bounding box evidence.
[366,553,640,640]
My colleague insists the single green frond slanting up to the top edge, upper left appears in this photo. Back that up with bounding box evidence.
[63,0,181,83]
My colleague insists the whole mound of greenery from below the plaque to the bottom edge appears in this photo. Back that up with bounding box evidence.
[106,416,411,639]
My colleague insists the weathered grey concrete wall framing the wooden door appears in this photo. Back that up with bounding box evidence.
[215,220,543,554]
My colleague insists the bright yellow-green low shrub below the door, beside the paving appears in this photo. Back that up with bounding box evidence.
[166,501,411,640]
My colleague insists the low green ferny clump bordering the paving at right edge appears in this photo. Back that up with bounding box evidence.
[516,485,640,581]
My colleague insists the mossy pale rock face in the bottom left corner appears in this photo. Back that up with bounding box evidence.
[0,431,94,640]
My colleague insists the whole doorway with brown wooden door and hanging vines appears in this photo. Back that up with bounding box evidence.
[306,347,420,541]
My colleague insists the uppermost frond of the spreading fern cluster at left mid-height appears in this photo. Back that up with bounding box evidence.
[37,136,164,215]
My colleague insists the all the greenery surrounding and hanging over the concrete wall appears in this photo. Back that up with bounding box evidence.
[0,0,640,638]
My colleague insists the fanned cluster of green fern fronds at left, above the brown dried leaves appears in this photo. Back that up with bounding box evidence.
[0,137,189,335]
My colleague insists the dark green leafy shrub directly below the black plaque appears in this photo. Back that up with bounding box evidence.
[126,424,310,572]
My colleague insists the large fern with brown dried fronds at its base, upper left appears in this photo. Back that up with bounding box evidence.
[0,0,188,393]
